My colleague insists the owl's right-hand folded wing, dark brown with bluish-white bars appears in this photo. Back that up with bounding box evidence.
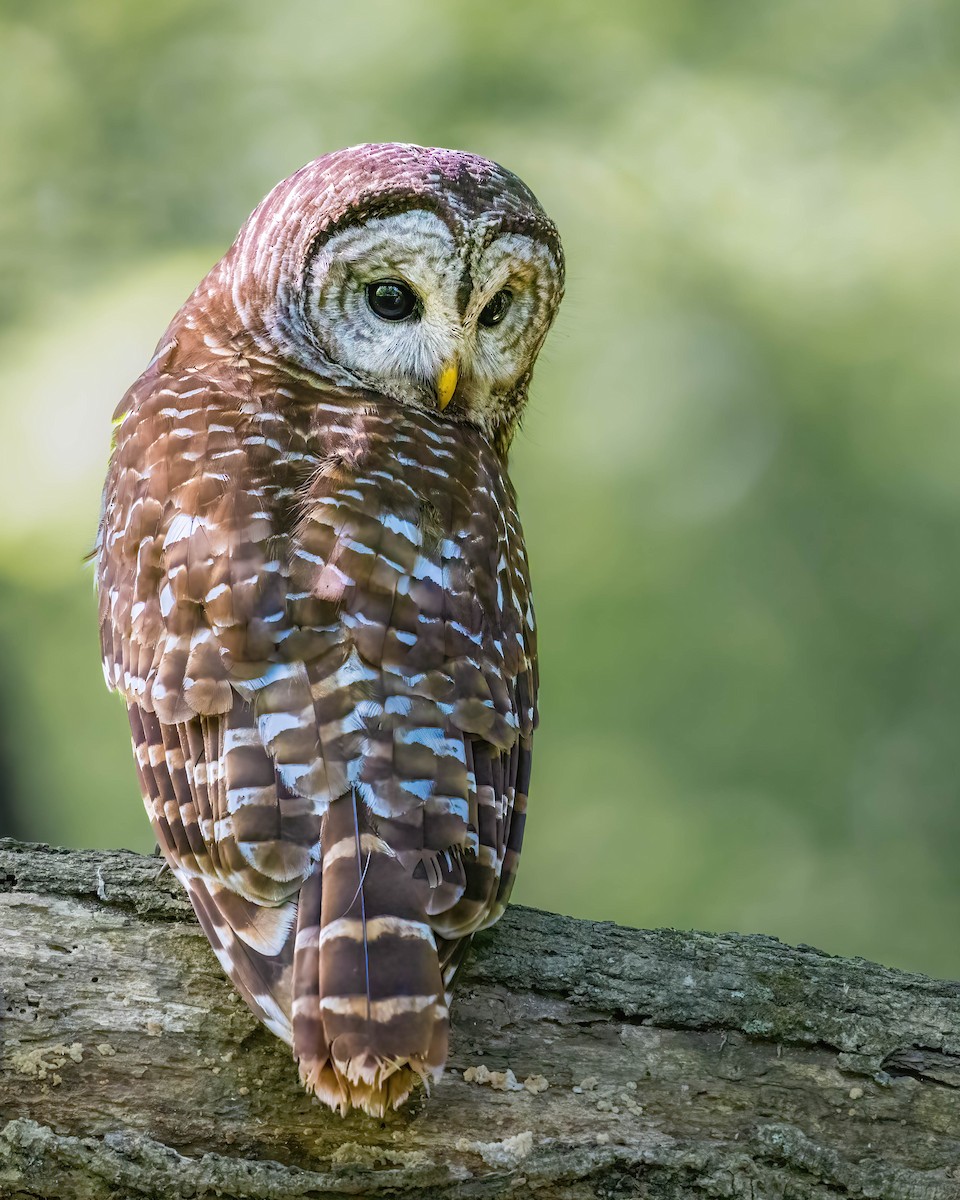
[290,415,536,940]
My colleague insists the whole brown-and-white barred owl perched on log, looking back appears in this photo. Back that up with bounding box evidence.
[96,145,563,1115]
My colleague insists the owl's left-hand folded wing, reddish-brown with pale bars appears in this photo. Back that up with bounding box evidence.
[97,360,320,1042]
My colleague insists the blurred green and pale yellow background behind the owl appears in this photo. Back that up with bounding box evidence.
[0,0,960,977]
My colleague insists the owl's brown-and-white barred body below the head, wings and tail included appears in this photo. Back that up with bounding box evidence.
[98,374,536,1114]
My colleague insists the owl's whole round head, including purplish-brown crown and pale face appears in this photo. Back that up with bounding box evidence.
[211,144,564,442]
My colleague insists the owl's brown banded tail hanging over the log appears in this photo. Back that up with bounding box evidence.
[293,793,448,1116]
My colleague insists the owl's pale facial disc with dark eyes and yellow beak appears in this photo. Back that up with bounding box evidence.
[306,209,559,430]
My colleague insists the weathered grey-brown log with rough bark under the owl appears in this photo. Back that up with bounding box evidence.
[0,840,960,1200]
